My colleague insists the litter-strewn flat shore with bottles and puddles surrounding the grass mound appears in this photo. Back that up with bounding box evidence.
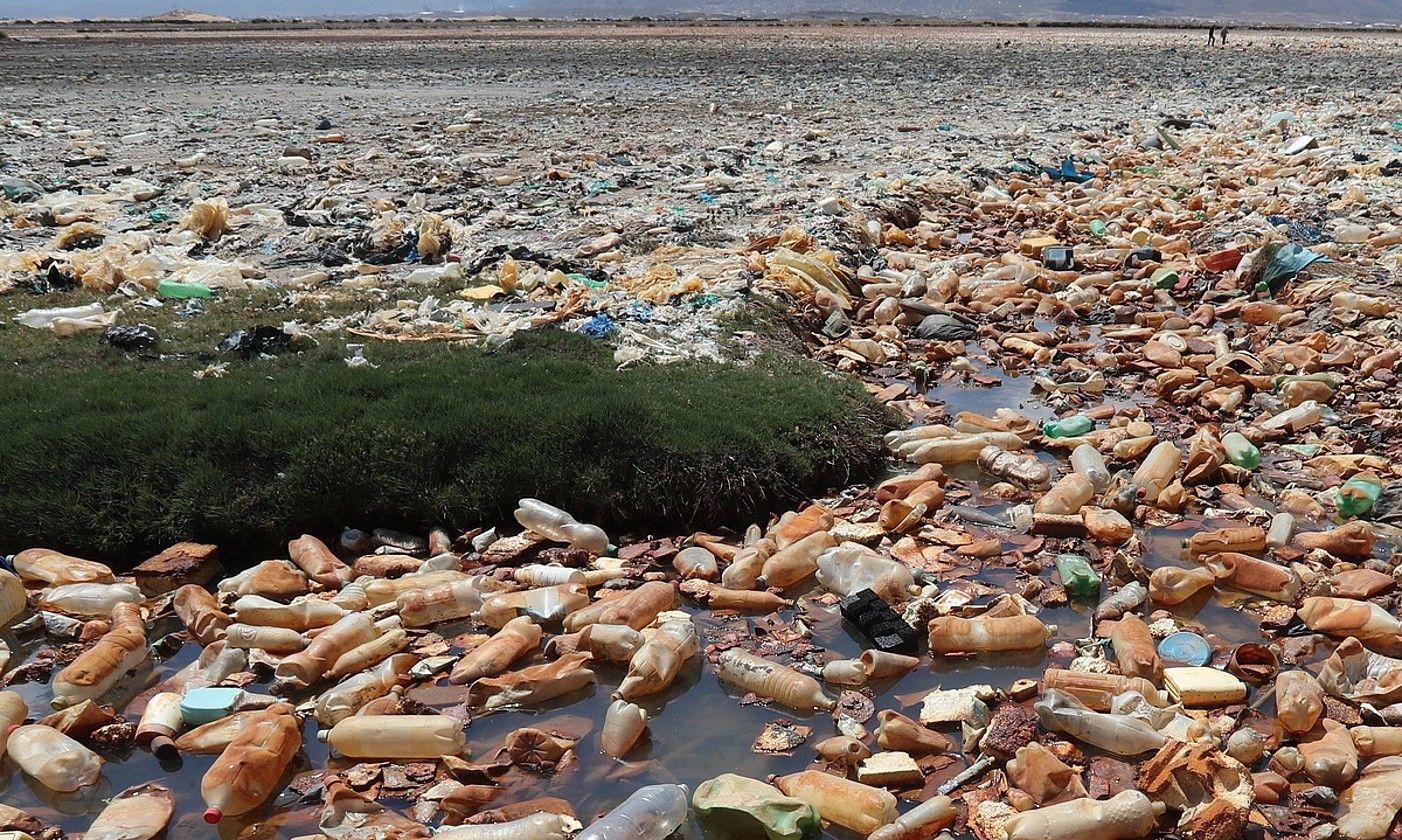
[0,16,1402,840]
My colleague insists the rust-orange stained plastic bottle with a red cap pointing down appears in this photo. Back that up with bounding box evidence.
[199,704,301,825]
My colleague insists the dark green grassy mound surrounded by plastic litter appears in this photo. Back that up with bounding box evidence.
[0,325,892,565]
